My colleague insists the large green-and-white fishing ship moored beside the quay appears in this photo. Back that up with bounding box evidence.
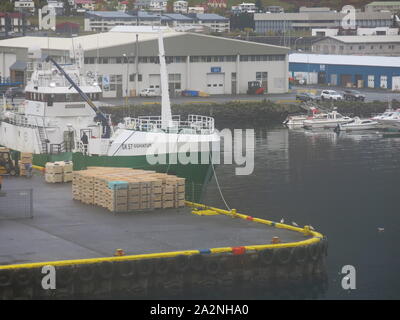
[0,30,220,200]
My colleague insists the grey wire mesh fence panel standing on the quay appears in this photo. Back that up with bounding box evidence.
[0,189,33,220]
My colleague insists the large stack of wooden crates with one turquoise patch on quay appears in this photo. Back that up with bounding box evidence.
[72,167,185,212]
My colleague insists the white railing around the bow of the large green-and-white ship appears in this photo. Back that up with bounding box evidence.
[124,115,214,134]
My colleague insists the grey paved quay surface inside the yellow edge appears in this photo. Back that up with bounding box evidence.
[0,176,307,265]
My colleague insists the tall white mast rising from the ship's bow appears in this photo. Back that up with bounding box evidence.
[158,28,172,130]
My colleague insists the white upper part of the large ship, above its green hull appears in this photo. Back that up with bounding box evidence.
[0,31,219,156]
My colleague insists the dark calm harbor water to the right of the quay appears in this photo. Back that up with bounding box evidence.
[203,126,400,299]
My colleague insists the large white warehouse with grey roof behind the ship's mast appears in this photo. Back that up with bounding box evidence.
[0,26,289,98]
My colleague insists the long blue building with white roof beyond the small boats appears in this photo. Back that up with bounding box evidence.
[289,53,400,91]
